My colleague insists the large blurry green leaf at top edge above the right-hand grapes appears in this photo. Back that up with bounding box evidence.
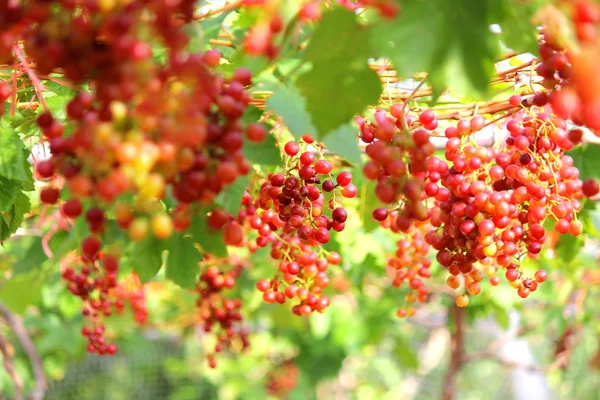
[372,0,500,98]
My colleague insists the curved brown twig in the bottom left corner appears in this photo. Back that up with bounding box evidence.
[0,304,47,400]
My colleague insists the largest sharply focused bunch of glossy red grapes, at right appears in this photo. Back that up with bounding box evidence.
[426,109,583,306]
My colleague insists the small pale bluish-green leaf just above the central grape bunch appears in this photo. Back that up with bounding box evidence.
[261,78,317,140]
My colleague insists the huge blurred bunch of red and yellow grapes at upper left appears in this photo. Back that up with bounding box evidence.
[0,0,267,360]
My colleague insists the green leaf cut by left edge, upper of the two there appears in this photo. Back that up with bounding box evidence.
[0,121,32,182]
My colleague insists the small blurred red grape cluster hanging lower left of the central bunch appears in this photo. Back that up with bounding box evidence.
[196,256,249,368]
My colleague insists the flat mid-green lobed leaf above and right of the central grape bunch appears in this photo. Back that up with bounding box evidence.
[296,9,382,137]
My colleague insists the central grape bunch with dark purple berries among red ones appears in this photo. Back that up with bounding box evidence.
[248,136,346,316]
